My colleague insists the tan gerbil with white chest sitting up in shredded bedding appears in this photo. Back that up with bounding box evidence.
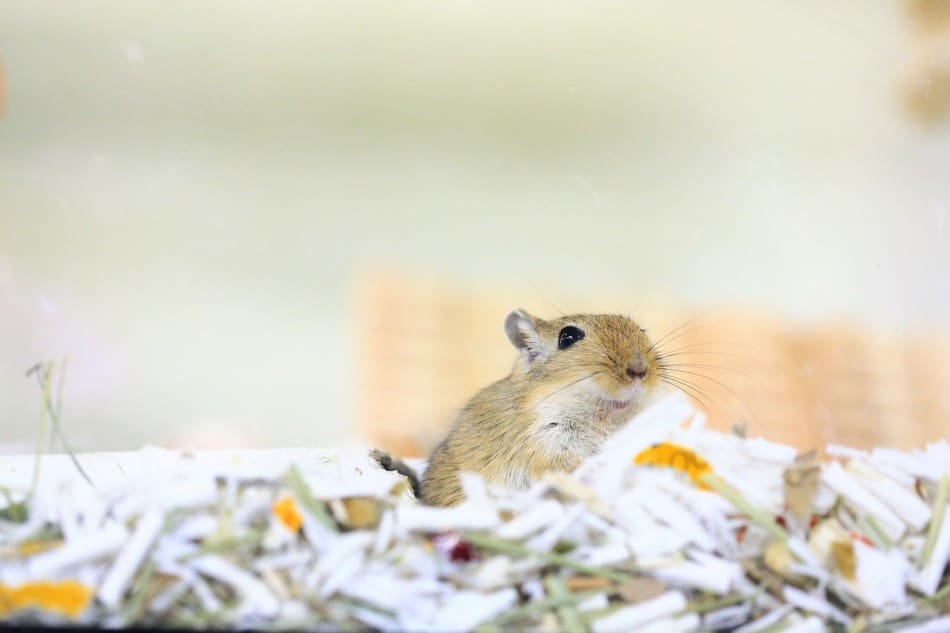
[422,310,660,506]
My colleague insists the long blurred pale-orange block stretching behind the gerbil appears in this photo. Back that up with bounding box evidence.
[356,274,950,456]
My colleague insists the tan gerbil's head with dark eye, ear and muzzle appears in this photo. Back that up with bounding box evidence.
[505,310,660,417]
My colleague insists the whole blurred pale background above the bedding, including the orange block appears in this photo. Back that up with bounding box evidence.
[0,0,950,453]
